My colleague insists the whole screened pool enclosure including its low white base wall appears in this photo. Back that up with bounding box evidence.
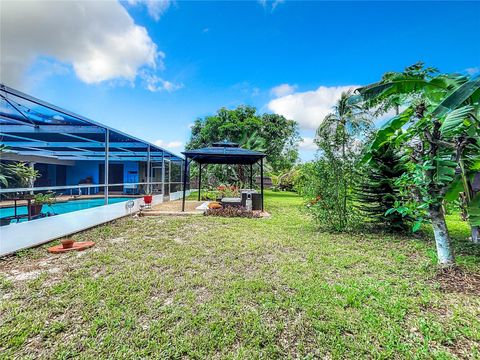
[0,84,190,257]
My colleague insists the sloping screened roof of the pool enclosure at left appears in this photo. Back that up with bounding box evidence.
[0,84,183,161]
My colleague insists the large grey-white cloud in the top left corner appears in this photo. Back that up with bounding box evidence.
[0,1,164,86]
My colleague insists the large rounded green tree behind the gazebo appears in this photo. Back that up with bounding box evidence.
[186,105,300,173]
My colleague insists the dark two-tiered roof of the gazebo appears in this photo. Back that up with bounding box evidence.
[182,141,266,165]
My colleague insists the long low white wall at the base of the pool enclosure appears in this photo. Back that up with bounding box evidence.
[0,191,190,256]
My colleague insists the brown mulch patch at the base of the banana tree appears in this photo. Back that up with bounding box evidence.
[434,267,480,295]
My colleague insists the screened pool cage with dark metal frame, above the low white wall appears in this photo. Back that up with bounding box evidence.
[0,84,184,204]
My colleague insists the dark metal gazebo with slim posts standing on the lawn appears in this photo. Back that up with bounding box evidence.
[182,141,267,211]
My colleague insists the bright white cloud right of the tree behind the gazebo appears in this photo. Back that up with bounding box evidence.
[267,85,359,130]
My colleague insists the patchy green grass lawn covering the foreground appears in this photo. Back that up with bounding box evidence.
[0,193,480,359]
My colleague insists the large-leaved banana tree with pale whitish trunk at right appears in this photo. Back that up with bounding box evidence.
[358,64,480,266]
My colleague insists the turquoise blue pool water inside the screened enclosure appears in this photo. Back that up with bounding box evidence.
[0,198,134,217]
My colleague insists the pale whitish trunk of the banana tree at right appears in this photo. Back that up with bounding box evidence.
[429,205,455,266]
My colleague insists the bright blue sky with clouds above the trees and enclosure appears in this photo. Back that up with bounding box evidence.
[0,0,480,161]
